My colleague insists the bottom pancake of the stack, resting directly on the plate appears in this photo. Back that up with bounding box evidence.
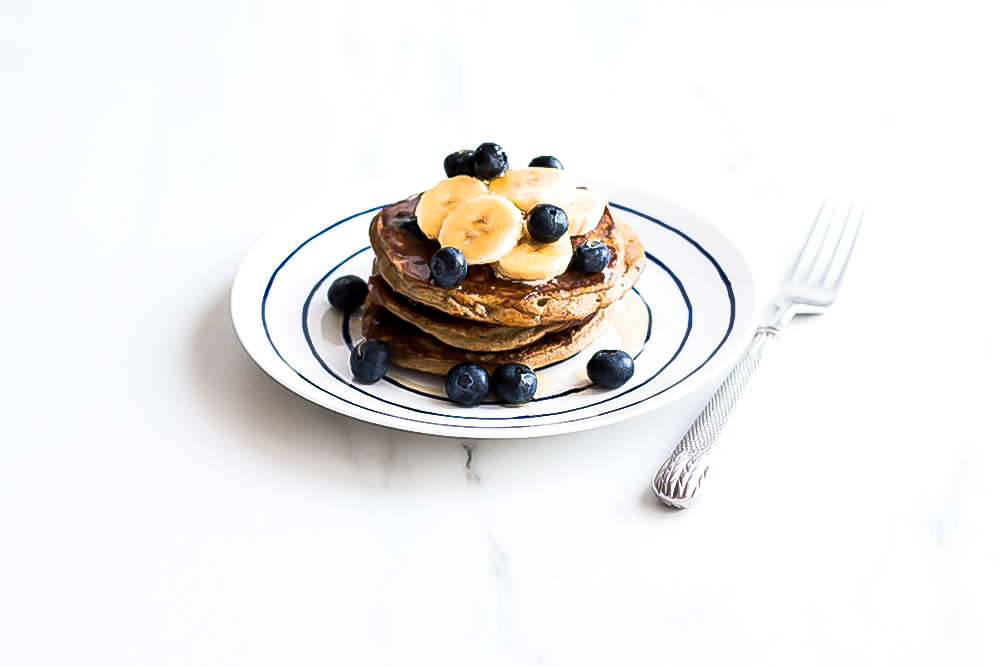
[361,298,611,375]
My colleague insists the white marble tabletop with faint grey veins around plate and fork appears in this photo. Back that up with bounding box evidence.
[0,0,1000,666]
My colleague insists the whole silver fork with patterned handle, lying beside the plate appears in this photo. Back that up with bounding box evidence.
[653,201,864,509]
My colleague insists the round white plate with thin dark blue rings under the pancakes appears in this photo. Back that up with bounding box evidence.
[231,179,755,438]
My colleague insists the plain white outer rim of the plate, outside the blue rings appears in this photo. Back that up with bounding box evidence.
[229,177,756,440]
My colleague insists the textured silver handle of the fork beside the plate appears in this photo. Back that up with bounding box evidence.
[653,326,784,509]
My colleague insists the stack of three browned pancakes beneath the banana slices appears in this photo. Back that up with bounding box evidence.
[362,195,646,375]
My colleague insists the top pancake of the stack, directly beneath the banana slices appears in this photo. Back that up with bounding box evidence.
[369,195,646,327]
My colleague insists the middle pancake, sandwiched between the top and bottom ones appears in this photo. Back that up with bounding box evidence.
[368,274,576,352]
